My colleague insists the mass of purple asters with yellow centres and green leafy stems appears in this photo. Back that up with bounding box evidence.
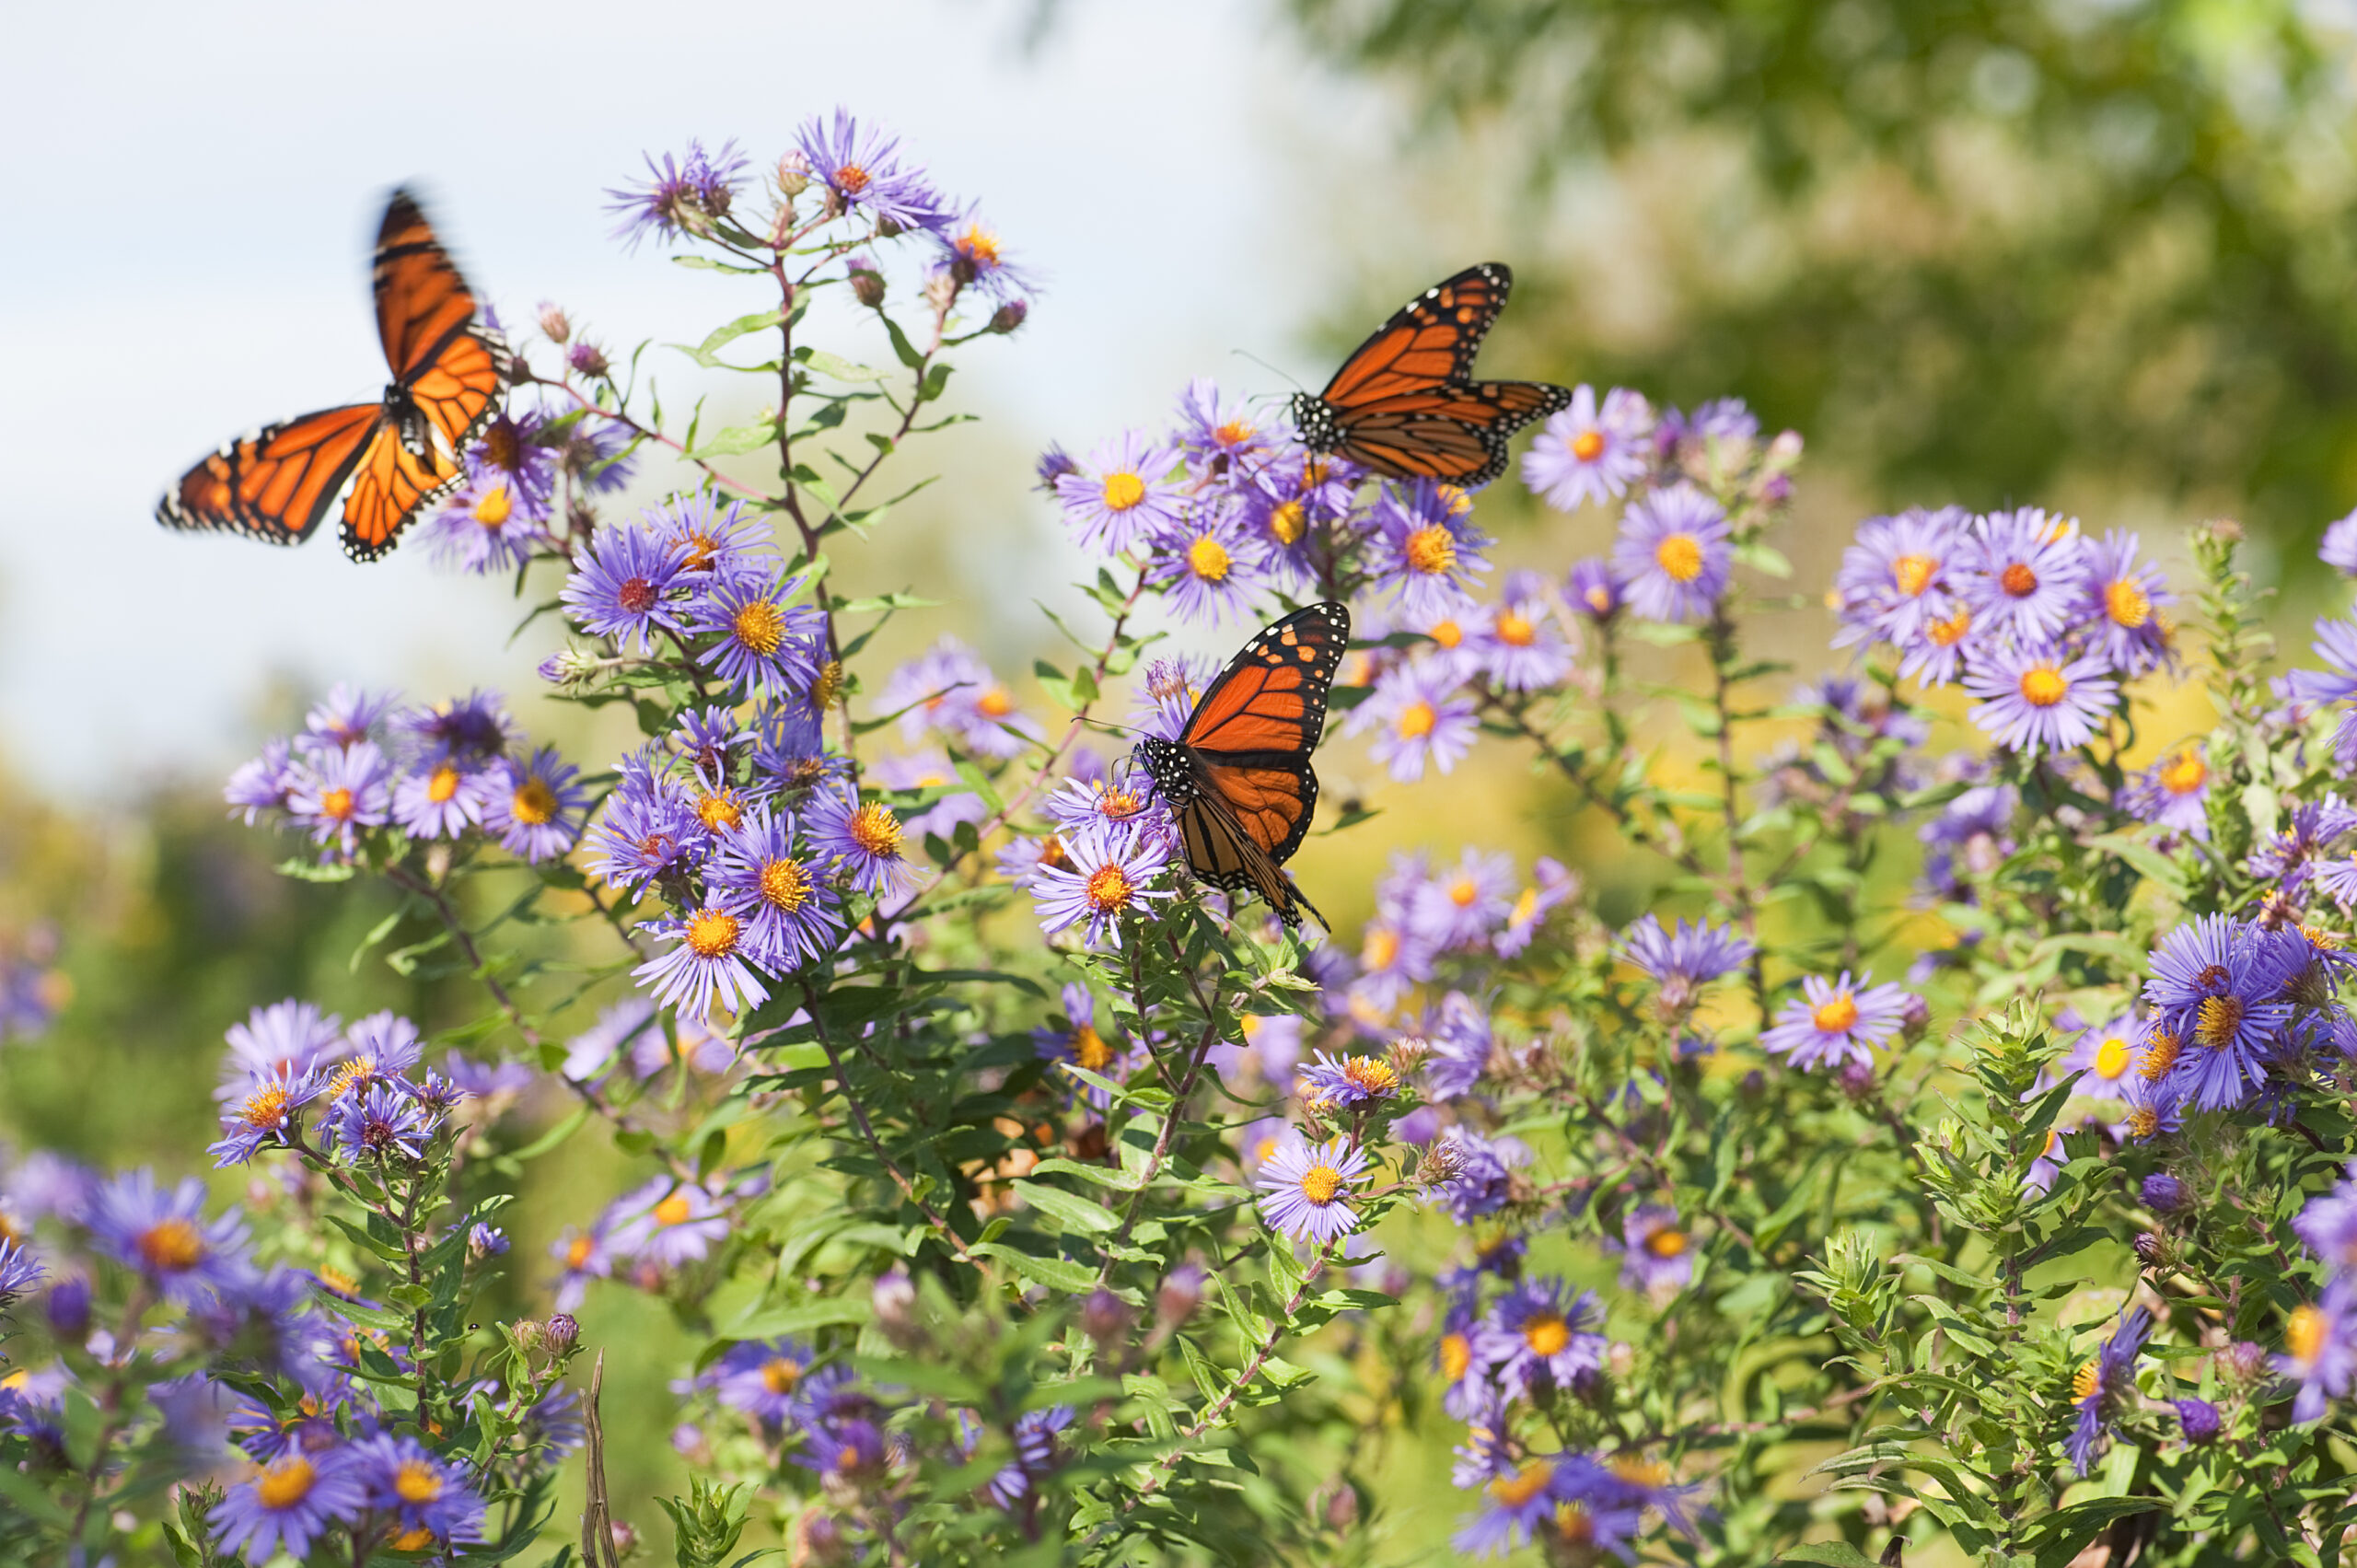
[22,110,2357,1568]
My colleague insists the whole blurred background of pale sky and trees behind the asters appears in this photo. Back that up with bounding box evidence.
[0,0,2357,1561]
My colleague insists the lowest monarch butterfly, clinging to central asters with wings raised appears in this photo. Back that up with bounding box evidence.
[1136,598,1351,929]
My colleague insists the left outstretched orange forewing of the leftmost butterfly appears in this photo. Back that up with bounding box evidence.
[156,403,399,545]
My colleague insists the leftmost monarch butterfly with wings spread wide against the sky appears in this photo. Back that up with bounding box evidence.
[156,191,509,561]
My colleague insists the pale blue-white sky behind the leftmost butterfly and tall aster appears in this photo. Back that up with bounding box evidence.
[0,0,1422,799]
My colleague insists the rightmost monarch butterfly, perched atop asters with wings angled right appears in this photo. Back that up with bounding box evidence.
[1292,261,1573,491]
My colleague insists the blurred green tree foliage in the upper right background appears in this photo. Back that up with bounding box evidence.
[1287,0,2357,545]
